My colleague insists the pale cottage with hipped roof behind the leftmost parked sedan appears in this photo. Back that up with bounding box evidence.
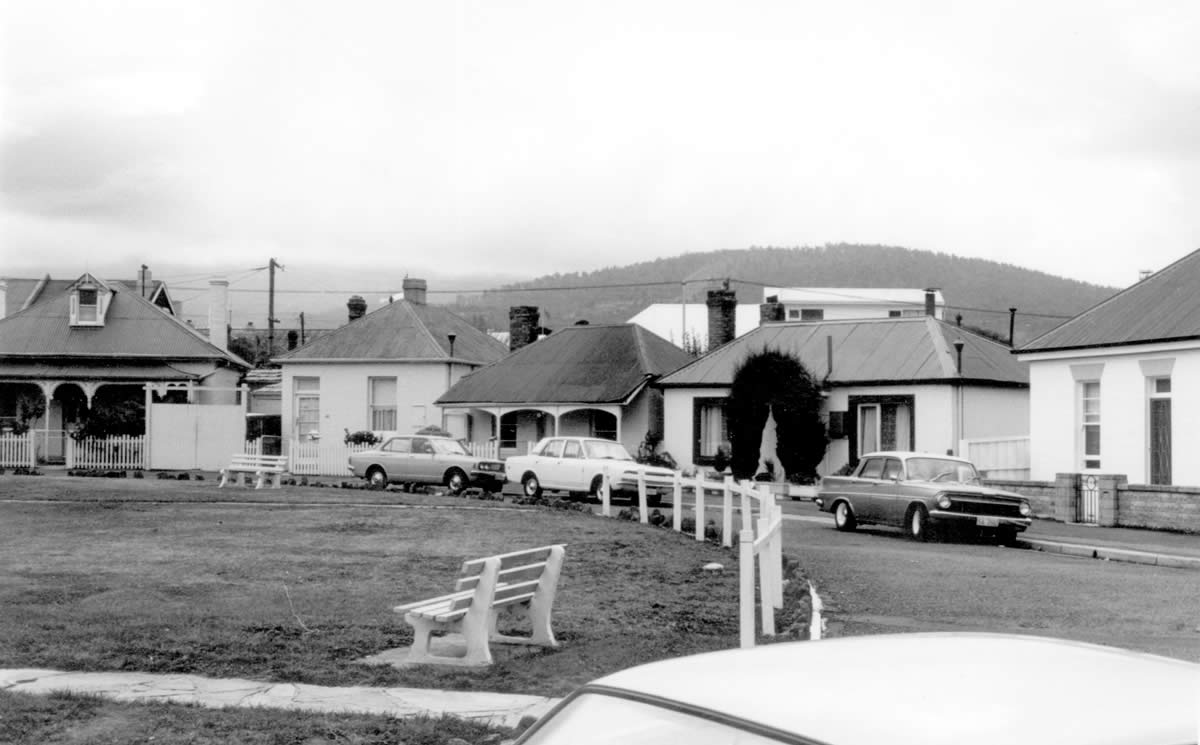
[276,280,508,444]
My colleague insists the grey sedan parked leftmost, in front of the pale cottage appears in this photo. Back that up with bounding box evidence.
[349,434,504,494]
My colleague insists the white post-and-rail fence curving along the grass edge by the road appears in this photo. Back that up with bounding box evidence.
[600,469,784,648]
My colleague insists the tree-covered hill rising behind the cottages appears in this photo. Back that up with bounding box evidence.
[441,244,1116,344]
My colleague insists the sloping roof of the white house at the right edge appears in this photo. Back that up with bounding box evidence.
[1016,251,1200,354]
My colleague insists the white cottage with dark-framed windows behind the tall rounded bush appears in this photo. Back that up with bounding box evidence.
[658,316,1028,475]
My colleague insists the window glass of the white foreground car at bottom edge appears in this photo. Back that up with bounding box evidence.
[527,693,780,745]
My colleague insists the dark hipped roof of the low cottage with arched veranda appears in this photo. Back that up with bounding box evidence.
[438,324,692,404]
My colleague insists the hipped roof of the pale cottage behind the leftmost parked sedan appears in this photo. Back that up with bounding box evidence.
[275,300,508,365]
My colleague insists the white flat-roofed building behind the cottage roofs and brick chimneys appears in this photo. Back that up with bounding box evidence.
[629,287,946,352]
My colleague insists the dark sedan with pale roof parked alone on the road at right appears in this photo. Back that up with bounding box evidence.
[816,452,1032,545]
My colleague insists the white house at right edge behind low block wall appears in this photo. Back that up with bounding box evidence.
[1018,251,1200,486]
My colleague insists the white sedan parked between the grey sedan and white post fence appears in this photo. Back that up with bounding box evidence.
[504,437,676,505]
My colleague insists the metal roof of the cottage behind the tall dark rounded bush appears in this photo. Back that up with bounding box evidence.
[658,316,1030,387]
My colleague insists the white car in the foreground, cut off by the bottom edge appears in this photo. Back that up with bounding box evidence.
[517,632,1200,745]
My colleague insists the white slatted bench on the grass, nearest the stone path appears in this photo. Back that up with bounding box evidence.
[394,545,565,667]
